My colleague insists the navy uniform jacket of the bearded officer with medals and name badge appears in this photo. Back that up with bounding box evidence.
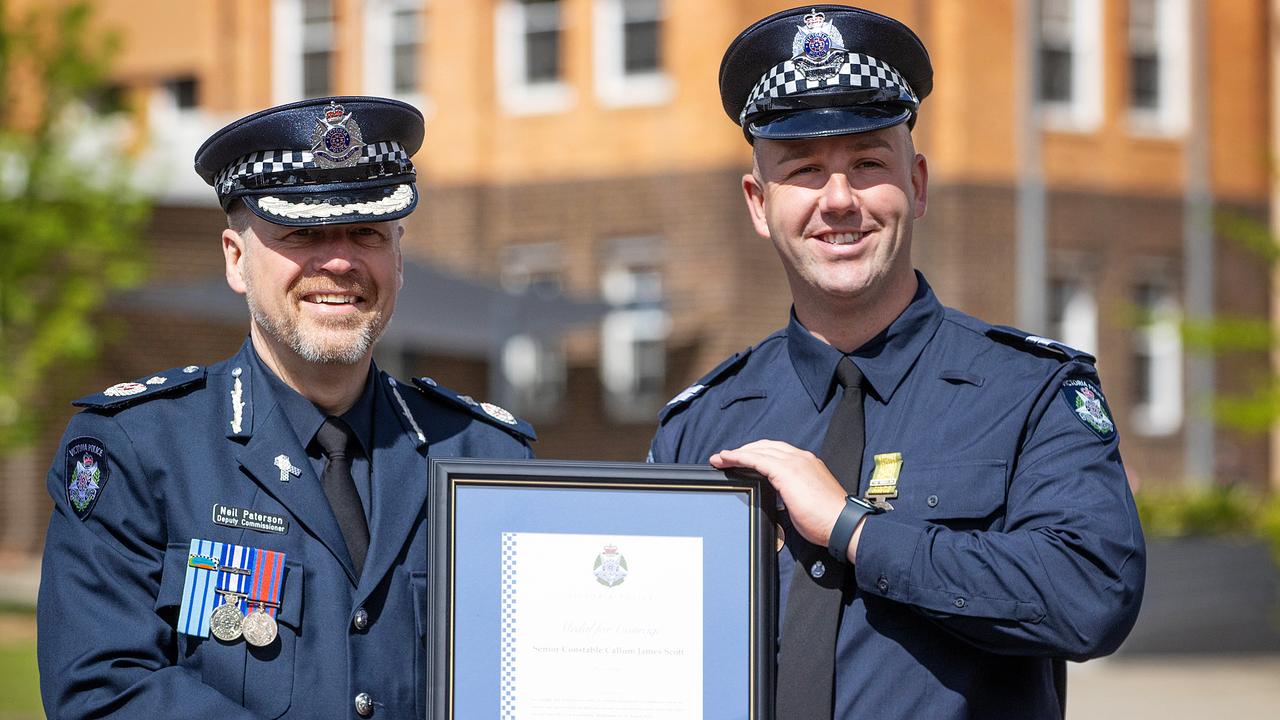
[38,342,532,720]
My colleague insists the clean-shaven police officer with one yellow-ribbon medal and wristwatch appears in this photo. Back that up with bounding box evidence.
[652,5,1144,720]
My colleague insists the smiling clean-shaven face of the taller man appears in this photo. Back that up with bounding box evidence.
[742,124,928,320]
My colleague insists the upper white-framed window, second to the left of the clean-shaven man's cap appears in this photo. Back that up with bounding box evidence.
[494,0,572,114]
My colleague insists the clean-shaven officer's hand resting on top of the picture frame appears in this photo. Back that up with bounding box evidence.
[710,439,861,548]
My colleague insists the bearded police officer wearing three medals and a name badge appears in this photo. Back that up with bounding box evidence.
[38,97,534,720]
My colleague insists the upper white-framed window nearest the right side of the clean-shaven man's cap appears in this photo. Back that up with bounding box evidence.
[1037,0,1102,132]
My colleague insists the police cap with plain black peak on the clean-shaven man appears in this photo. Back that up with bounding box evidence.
[719,5,933,142]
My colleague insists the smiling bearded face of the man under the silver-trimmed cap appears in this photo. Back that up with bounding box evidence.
[223,210,403,365]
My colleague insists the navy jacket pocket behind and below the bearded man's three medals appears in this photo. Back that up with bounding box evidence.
[155,542,305,717]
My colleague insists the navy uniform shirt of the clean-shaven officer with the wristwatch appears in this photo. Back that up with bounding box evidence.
[652,275,1146,720]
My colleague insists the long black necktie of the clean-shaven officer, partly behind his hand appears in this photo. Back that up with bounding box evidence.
[777,357,864,720]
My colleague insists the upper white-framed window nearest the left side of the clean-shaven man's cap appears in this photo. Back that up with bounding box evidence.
[595,0,671,105]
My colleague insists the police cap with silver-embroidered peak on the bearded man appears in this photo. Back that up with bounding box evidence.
[196,96,424,225]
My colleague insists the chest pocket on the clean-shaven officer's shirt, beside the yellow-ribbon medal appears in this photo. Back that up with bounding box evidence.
[890,460,1009,529]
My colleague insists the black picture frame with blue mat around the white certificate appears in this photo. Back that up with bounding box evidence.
[426,459,777,720]
